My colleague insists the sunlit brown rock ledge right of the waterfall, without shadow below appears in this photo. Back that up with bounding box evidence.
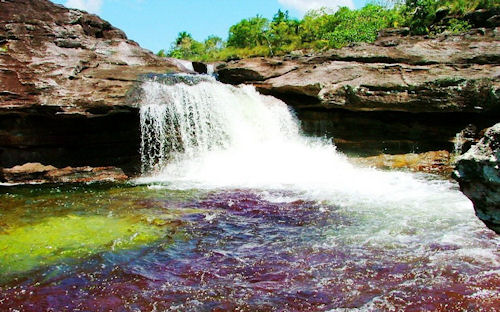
[218,29,500,113]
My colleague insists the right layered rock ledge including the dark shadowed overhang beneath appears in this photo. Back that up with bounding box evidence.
[217,28,500,154]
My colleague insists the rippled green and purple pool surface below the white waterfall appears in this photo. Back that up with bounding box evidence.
[0,181,500,311]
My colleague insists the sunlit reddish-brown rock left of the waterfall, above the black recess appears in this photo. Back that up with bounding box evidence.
[0,0,186,113]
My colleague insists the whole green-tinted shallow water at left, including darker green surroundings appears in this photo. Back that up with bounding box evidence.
[0,186,209,283]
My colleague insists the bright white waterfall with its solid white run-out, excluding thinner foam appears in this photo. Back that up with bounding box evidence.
[137,76,471,219]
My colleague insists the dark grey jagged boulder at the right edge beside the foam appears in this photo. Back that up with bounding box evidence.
[454,123,500,234]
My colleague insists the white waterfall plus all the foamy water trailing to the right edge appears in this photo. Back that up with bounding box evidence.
[138,73,500,258]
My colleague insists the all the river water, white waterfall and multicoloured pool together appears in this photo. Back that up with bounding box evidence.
[0,76,500,311]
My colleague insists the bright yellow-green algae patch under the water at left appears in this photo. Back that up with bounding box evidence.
[0,215,164,274]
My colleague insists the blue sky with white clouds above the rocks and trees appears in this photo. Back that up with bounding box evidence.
[53,0,368,52]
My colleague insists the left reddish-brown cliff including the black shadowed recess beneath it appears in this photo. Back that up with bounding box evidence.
[0,0,186,170]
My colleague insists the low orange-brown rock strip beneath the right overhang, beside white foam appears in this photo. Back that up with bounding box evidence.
[351,151,453,176]
